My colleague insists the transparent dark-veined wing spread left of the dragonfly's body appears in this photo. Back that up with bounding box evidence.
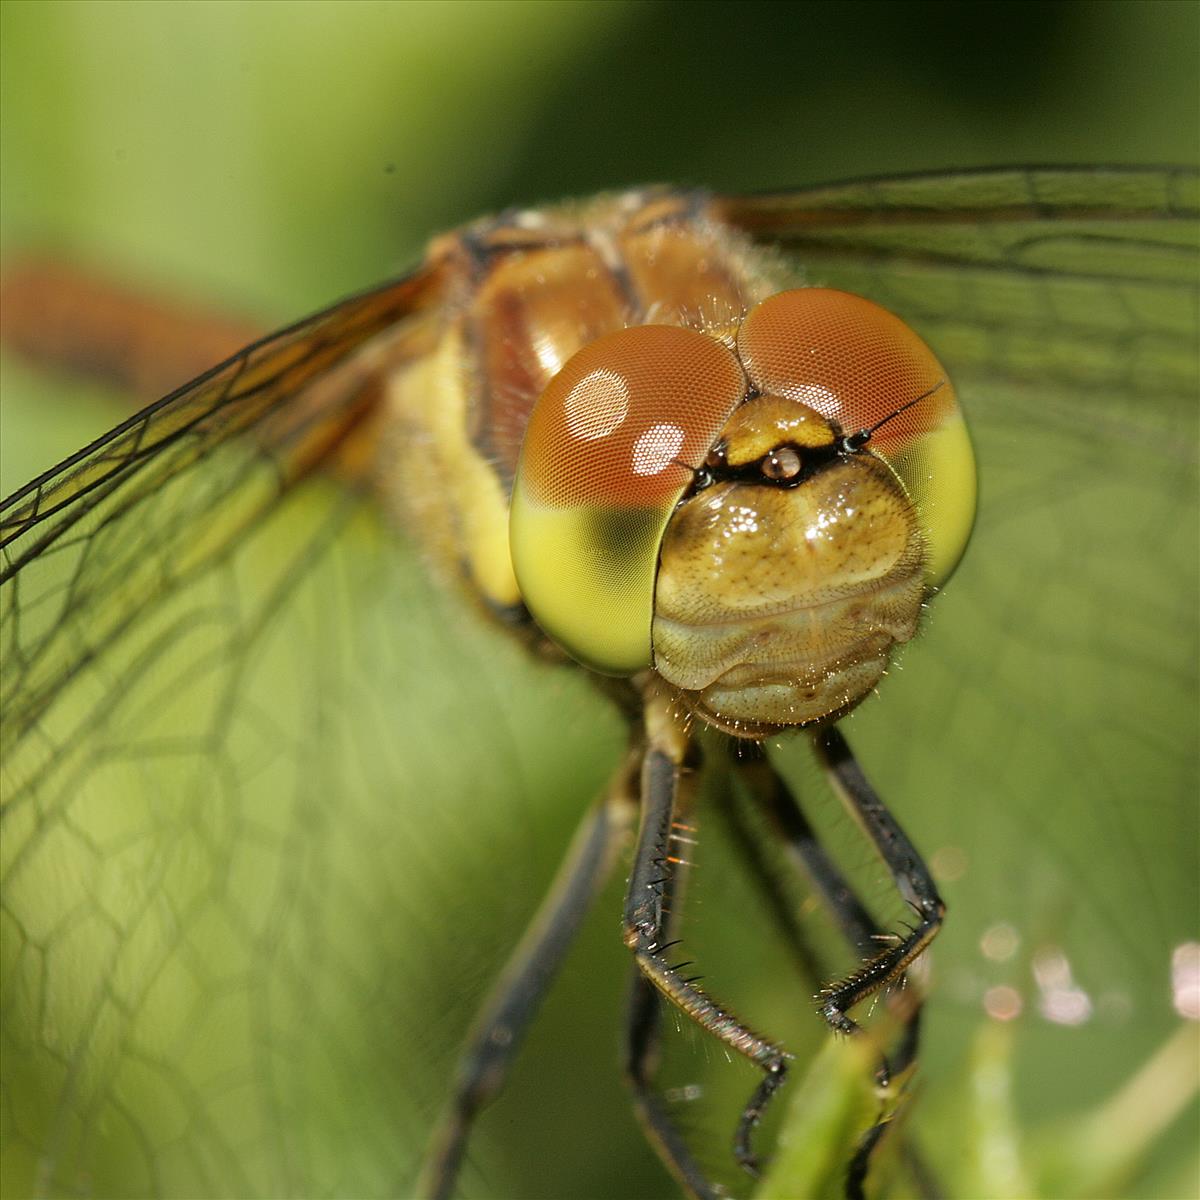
[0,253,648,1196]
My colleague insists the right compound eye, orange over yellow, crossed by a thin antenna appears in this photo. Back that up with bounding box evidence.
[738,288,976,587]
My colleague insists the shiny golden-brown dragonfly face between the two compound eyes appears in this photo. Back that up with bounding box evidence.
[653,396,928,736]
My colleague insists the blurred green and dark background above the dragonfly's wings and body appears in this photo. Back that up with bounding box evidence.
[0,0,1200,463]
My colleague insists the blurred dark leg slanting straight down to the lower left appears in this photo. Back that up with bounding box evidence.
[416,750,641,1200]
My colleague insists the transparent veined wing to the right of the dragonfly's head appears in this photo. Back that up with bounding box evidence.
[718,168,1200,1194]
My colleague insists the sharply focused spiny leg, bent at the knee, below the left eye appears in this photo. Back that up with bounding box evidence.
[624,744,788,1180]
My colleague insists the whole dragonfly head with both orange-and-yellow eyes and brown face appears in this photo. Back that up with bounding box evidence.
[510,288,974,737]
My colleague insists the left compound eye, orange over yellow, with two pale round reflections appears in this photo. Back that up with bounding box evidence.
[509,325,746,674]
